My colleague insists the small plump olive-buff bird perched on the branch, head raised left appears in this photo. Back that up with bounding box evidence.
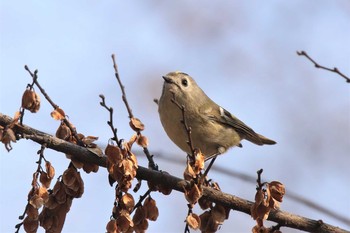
[158,71,276,160]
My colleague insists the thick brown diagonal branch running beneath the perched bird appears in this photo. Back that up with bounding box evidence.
[0,113,349,233]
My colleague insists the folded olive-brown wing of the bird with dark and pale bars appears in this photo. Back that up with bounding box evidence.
[202,106,263,145]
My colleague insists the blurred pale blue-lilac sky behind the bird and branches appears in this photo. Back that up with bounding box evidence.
[0,0,350,232]
